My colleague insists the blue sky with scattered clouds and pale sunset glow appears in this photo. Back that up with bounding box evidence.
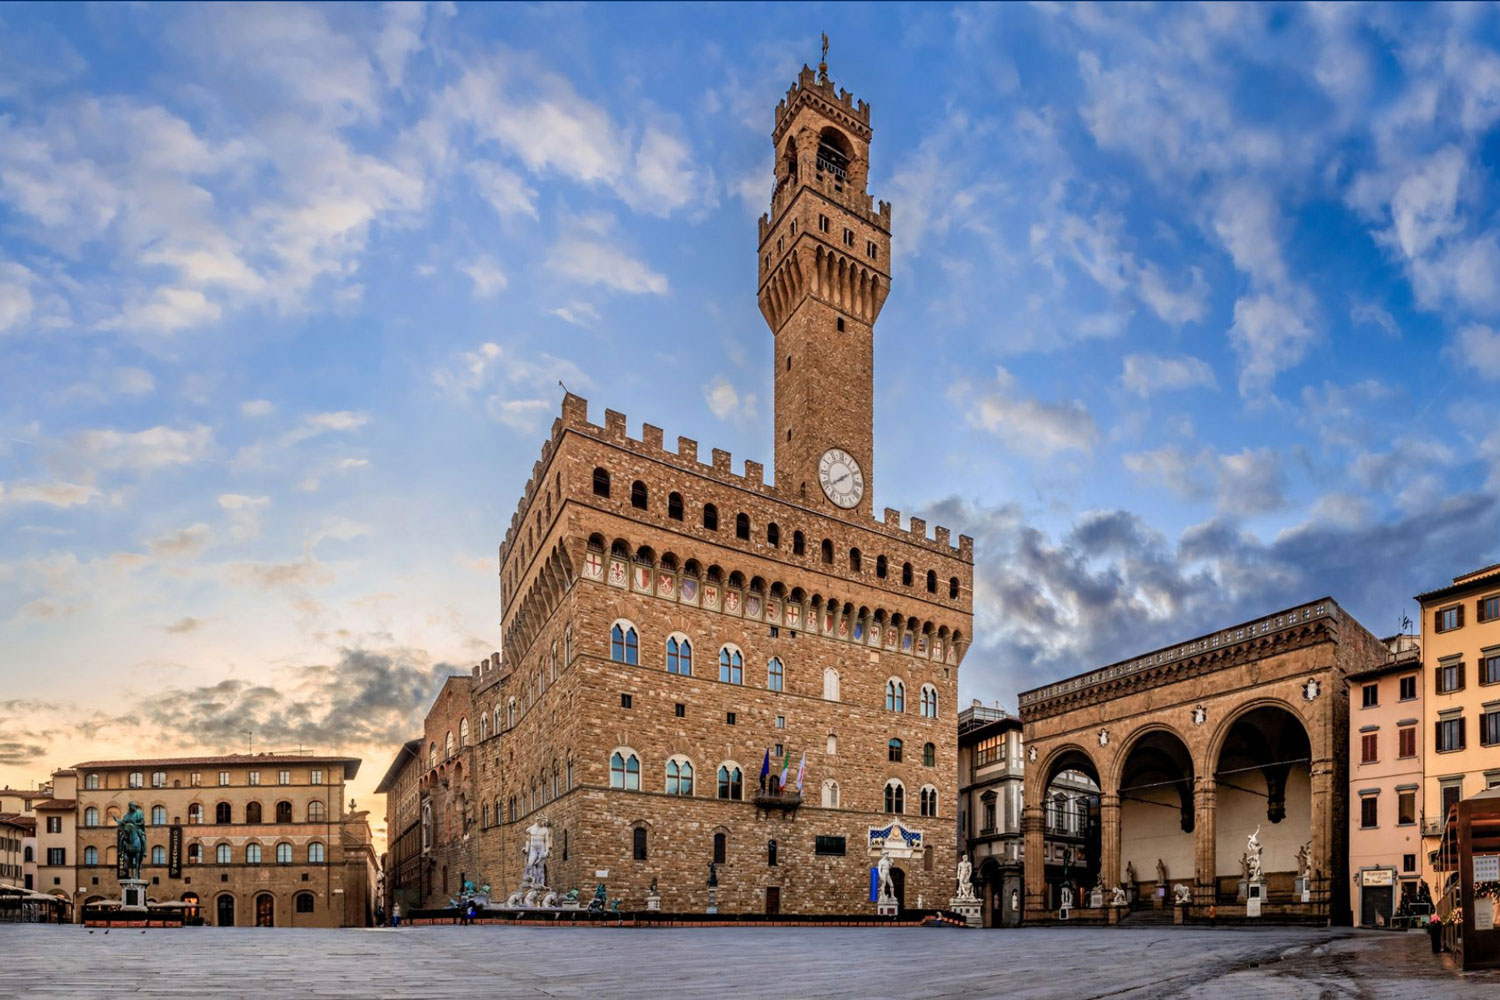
[0,3,1500,845]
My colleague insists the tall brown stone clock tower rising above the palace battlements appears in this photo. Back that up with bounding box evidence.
[758,44,891,516]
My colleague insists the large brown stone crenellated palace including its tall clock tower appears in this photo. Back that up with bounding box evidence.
[387,56,974,913]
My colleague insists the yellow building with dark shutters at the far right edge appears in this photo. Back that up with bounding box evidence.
[1416,564,1500,897]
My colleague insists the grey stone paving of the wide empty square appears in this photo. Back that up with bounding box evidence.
[0,925,1500,1000]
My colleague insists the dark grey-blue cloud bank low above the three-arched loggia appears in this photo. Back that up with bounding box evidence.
[918,493,1500,708]
